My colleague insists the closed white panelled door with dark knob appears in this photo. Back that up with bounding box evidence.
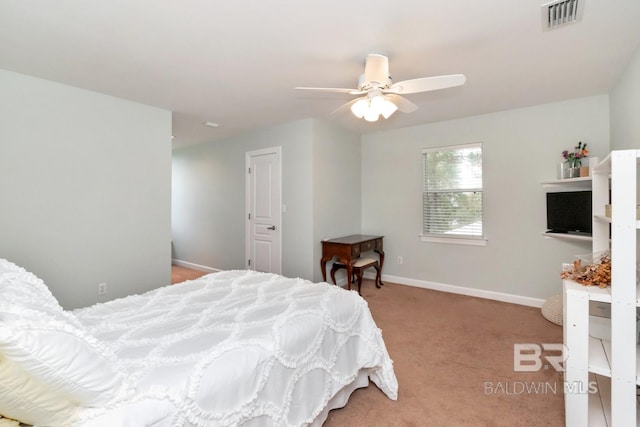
[246,147,282,274]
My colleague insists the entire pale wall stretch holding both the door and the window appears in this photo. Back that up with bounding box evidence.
[173,95,609,299]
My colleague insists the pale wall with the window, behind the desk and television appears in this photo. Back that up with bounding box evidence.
[362,95,609,299]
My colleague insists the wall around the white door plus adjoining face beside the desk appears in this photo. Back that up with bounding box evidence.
[173,119,360,281]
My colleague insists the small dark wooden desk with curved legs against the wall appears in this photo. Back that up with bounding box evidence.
[320,234,384,289]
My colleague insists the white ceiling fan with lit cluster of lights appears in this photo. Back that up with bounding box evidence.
[295,53,467,122]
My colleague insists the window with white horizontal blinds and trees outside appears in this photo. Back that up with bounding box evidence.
[421,143,486,245]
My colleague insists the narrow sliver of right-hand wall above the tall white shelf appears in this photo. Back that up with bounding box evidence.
[610,48,640,150]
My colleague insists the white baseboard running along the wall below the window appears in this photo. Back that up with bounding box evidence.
[364,272,544,308]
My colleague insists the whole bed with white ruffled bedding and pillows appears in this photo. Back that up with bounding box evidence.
[0,260,398,427]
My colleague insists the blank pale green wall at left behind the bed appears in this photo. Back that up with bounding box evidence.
[0,70,171,308]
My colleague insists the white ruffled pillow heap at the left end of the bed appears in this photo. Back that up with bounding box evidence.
[0,263,129,425]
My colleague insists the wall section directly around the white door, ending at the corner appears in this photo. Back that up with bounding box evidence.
[172,119,314,279]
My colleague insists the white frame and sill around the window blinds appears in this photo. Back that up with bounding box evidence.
[419,142,487,246]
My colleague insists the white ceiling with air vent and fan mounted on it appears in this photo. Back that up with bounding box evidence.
[0,0,640,147]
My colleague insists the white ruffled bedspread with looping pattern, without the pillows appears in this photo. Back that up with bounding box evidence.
[74,271,398,427]
